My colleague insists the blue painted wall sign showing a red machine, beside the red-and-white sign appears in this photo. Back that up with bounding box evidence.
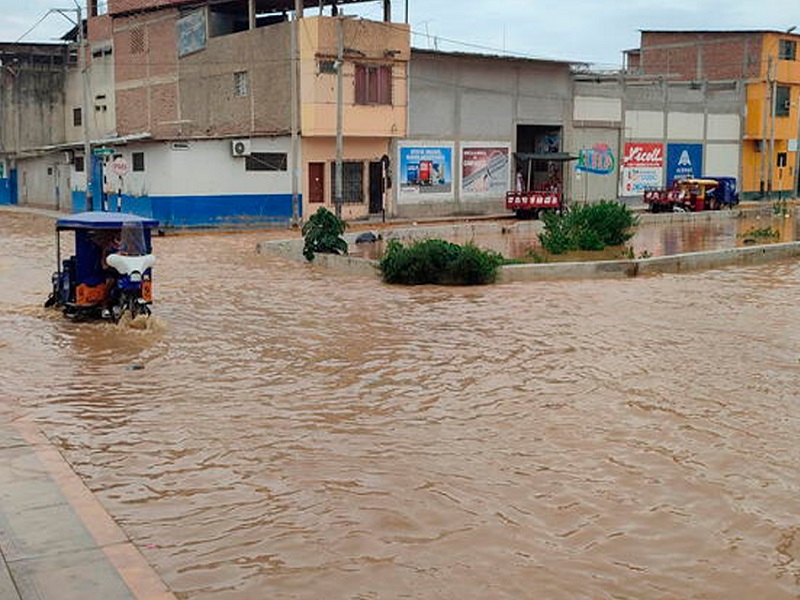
[399,146,453,198]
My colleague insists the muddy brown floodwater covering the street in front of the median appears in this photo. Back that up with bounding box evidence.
[0,212,800,600]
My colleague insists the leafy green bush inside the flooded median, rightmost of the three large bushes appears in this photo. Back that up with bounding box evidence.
[539,200,638,254]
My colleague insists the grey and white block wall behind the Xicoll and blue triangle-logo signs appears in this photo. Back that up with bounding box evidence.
[570,75,745,201]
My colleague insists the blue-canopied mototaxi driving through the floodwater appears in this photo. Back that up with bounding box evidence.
[45,212,158,323]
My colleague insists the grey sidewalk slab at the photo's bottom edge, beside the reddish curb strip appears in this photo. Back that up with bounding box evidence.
[8,548,134,600]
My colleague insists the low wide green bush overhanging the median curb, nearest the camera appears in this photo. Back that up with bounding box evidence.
[379,240,503,285]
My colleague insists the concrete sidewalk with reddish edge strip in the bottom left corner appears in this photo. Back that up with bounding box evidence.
[0,421,175,600]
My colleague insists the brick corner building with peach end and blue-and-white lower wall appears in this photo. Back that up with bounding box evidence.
[4,0,410,226]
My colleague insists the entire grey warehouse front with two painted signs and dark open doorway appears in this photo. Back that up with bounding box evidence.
[392,49,572,217]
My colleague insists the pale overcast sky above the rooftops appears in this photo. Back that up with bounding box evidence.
[0,0,800,68]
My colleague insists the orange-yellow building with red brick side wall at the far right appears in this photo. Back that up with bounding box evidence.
[626,29,800,198]
